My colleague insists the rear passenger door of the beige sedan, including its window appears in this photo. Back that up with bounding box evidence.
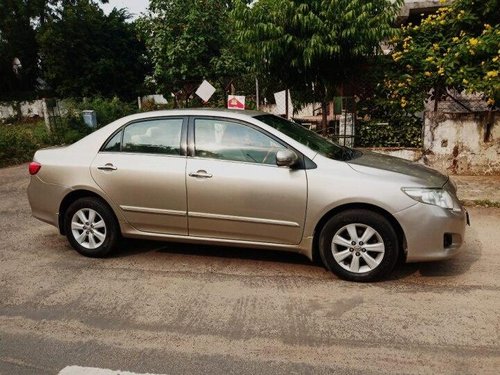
[91,117,187,235]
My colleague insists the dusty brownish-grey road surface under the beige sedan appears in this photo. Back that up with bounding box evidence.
[0,166,500,375]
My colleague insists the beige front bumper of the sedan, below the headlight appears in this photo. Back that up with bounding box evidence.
[394,203,468,262]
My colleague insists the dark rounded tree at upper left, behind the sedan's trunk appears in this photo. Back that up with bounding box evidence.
[38,0,146,98]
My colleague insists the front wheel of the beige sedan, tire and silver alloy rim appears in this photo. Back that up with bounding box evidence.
[318,209,399,282]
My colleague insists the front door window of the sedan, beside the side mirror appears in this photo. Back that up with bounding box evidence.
[194,119,285,165]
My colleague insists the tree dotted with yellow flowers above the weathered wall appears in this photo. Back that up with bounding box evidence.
[385,0,500,110]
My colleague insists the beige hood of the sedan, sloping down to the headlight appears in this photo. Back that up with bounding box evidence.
[347,151,448,187]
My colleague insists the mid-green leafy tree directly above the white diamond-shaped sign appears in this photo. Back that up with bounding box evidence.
[140,0,246,106]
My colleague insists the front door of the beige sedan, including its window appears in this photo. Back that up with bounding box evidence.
[186,117,307,244]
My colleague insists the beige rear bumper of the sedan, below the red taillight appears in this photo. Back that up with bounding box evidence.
[28,176,71,228]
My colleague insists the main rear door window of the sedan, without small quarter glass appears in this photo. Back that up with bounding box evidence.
[121,118,183,155]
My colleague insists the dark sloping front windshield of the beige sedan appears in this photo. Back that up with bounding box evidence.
[255,115,355,160]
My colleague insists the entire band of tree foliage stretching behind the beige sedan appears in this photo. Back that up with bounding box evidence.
[0,0,500,120]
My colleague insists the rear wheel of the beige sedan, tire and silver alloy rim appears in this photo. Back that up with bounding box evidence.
[64,197,120,258]
